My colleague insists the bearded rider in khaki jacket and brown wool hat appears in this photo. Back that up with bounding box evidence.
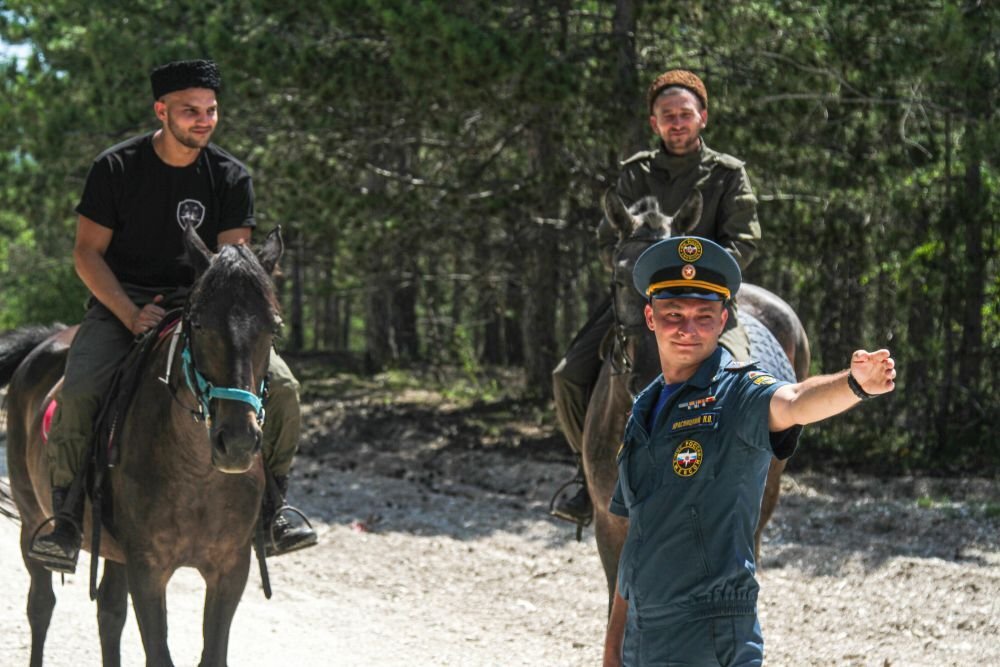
[552,70,761,524]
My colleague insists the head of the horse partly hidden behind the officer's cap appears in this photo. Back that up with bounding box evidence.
[602,190,703,396]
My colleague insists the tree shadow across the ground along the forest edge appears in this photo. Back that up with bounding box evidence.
[284,360,1000,576]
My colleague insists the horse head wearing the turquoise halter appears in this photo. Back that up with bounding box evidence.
[182,226,284,473]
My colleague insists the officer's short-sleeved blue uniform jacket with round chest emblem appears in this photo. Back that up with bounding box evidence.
[610,348,788,631]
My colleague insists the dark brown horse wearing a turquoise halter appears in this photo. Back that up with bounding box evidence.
[0,229,282,667]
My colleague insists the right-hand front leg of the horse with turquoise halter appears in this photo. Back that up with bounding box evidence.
[199,545,250,667]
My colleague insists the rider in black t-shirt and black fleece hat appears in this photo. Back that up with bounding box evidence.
[29,60,316,572]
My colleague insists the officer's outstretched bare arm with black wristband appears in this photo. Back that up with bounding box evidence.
[769,350,896,431]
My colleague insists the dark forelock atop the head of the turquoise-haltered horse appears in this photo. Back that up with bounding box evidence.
[191,244,281,314]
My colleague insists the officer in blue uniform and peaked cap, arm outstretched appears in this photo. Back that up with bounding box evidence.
[604,237,896,667]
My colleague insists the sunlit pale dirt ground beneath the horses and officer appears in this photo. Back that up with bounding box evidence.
[0,376,1000,667]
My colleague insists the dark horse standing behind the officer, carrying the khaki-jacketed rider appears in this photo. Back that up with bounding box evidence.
[583,191,809,599]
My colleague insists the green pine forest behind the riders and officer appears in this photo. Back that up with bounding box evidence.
[0,0,1000,476]
